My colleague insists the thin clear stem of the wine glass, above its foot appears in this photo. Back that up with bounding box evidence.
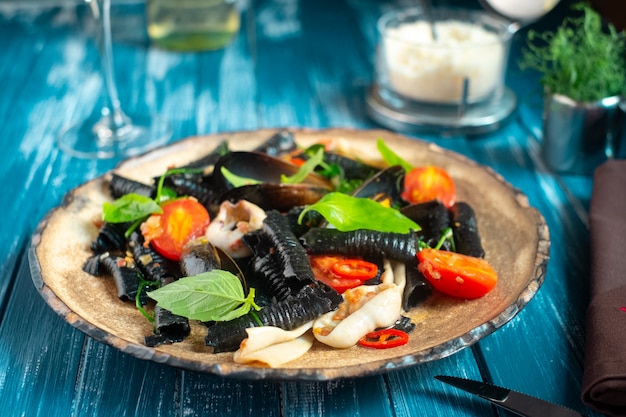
[87,0,129,131]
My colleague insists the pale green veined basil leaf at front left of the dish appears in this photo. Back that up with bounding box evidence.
[148,270,260,321]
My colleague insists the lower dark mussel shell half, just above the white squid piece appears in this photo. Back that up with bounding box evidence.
[222,183,330,212]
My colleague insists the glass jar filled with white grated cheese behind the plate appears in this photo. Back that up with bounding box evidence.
[383,20,506,103]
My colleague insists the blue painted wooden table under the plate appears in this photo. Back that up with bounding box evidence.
[0,0,616,417]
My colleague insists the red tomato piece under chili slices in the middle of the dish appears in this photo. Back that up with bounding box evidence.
[309,255,378,294]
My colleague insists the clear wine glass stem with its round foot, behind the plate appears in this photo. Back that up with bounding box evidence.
[57,0,172,159]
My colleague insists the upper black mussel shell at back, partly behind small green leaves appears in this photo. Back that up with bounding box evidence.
[213,151,333,192]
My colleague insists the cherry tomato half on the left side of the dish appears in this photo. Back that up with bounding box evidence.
[142,198,210,261]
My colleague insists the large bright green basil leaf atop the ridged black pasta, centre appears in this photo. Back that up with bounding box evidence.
[298,192,421,233]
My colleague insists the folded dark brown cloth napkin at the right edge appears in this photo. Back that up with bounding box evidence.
[582,160,626,417]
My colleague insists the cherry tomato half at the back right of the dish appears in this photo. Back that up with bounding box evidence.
[402,165,456,208]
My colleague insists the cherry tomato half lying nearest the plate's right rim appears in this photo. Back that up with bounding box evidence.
[417,248,498,299]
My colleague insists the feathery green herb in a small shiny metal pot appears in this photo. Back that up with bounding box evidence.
[521,2,626,174]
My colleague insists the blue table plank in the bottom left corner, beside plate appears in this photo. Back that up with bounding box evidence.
[0,257,84,417]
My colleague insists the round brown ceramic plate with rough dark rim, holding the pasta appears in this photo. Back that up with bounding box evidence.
[31,129,550,380]
